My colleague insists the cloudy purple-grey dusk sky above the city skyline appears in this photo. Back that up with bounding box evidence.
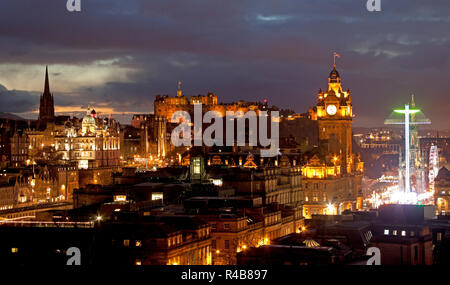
[0,0,450,129]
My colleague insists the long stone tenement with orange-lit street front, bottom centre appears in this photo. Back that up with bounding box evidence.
[184,196,304,265]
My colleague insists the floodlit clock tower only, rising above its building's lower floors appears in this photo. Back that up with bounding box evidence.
[317,64,353,173]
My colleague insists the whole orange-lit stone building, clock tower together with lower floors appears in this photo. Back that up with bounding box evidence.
[302,62,364,218]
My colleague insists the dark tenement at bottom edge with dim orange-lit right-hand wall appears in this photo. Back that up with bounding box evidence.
[93,214,212,266]
